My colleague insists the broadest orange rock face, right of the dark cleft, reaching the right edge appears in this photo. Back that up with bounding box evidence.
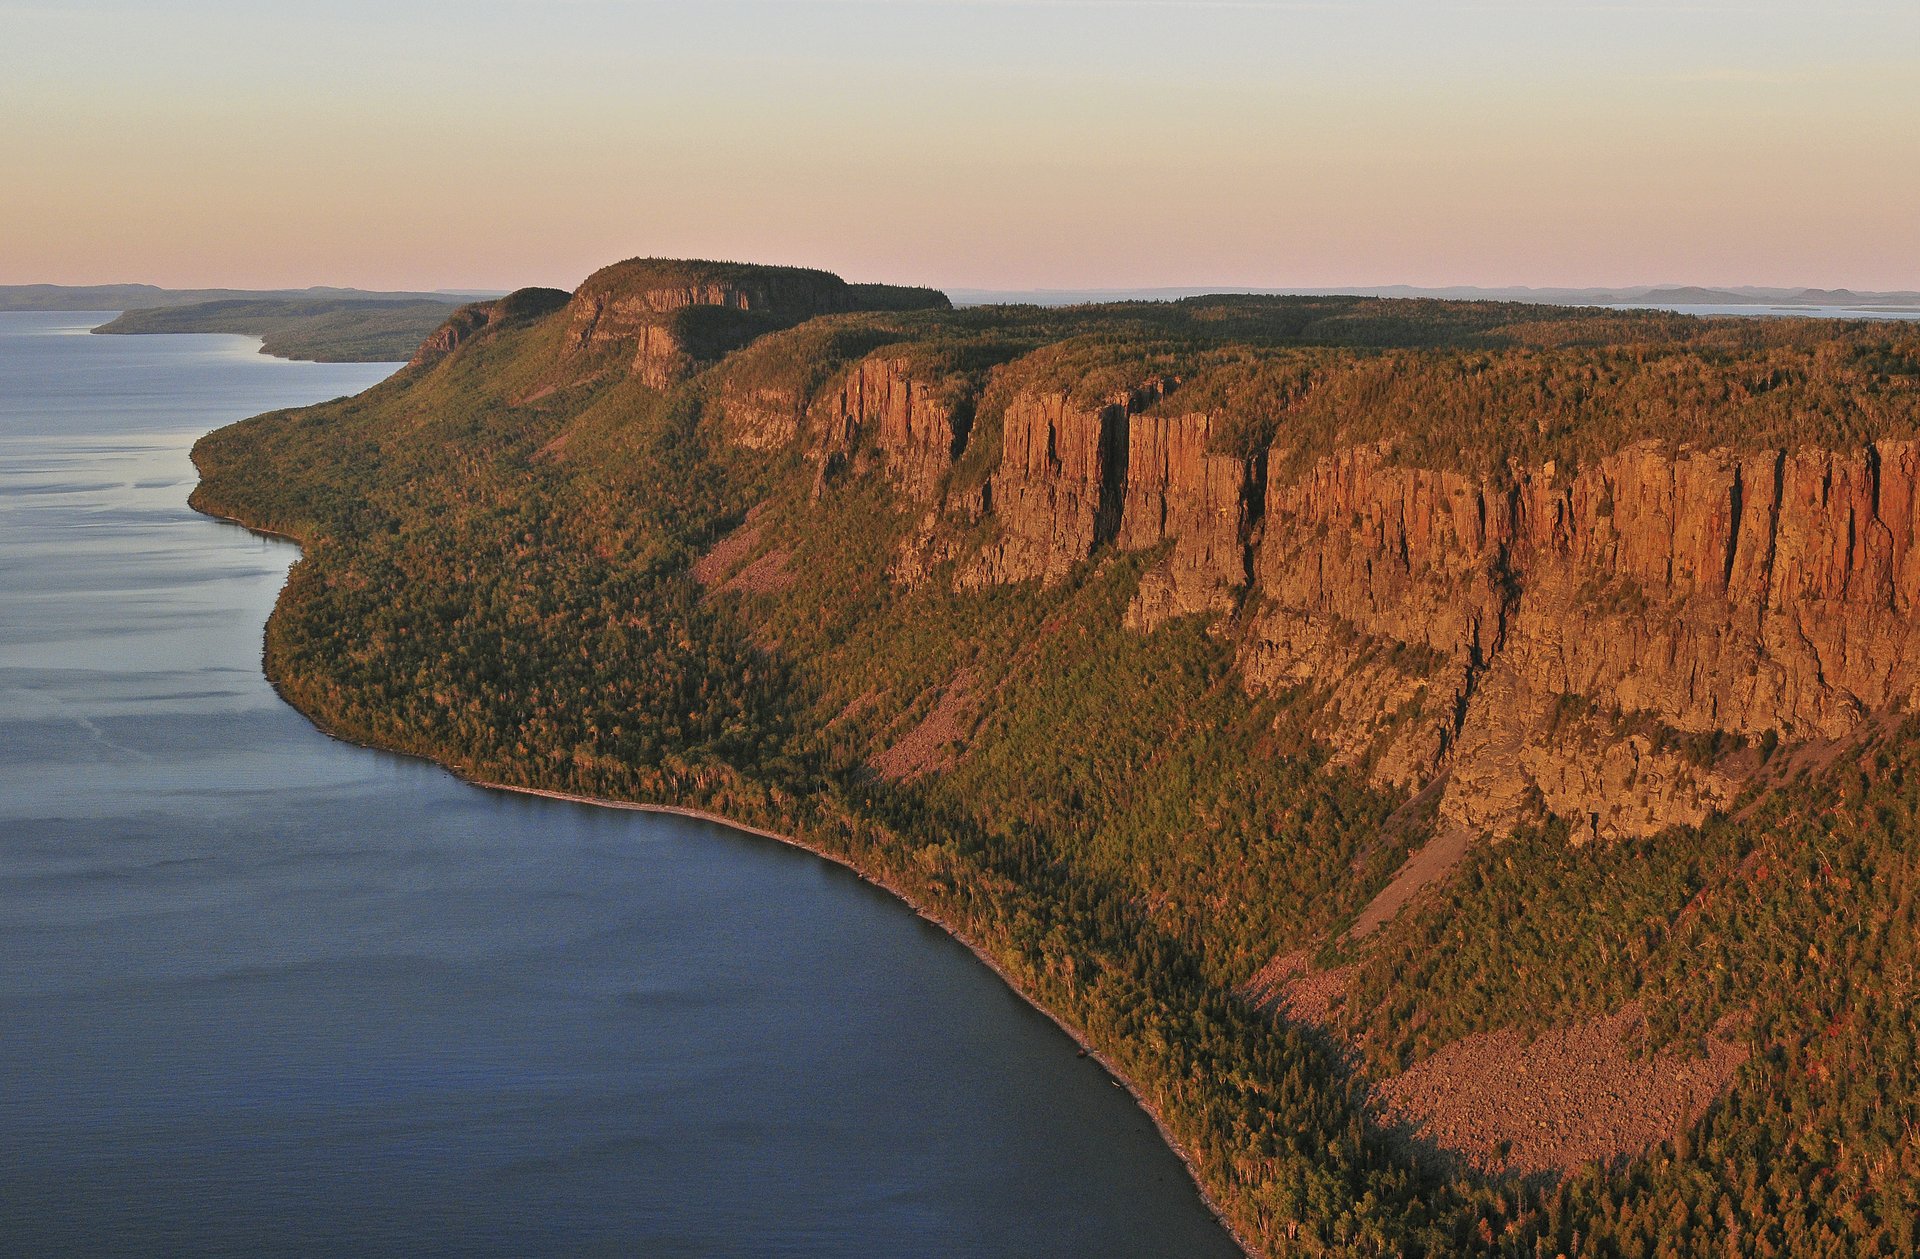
[1242,441,1920,835]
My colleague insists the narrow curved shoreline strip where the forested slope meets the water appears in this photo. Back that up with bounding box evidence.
[188,487,1261,1259]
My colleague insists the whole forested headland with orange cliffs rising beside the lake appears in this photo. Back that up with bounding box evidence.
[194,259,1920,1257]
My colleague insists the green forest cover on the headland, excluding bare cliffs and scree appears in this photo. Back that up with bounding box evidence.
[196,291,1920,1255]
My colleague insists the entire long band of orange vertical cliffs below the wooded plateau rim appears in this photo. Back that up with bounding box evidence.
[698,330,1920,837]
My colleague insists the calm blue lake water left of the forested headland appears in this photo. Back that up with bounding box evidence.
[0,315,1236,1259]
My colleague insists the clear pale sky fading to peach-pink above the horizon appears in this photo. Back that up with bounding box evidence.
[0,0,1920,290]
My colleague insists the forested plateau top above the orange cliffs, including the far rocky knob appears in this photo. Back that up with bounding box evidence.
[408,257,1920,478]
